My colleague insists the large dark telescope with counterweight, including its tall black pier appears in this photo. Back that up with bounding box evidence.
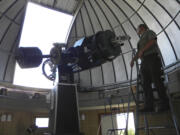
[16,30,130,135]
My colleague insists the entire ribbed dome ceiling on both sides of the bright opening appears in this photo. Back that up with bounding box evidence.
[0,0,180,87]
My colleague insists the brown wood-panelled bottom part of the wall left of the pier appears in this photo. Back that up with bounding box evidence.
[0,110,48,135]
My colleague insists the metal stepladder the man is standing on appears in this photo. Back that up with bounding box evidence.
[102,49,180,135]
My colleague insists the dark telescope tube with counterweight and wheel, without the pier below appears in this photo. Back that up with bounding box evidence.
[16,30,130,81]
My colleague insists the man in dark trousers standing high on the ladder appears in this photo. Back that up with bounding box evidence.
[130,24,168,112]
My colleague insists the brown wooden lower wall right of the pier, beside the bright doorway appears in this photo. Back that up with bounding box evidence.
[80,105,179,135]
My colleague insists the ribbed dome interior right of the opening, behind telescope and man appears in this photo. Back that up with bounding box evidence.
[68,0,180,87]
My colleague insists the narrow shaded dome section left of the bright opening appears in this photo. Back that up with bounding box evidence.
[0,0,26,82]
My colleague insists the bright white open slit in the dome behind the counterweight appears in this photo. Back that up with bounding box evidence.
[14,2,72,88]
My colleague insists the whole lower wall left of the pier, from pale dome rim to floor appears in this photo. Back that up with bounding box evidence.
[0,84,50,135]
